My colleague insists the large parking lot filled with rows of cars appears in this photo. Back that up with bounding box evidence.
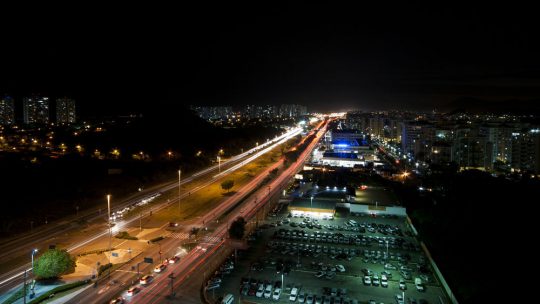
[207,205,448,304]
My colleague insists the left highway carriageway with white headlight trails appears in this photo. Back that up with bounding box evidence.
[0,124,301,294]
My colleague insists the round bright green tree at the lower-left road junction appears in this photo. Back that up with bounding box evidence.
[34,249,75,279]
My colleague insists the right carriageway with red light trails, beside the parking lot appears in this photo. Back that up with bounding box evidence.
[69,120,325,304]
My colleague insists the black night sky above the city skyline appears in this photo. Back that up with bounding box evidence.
[0,2,540,115]
